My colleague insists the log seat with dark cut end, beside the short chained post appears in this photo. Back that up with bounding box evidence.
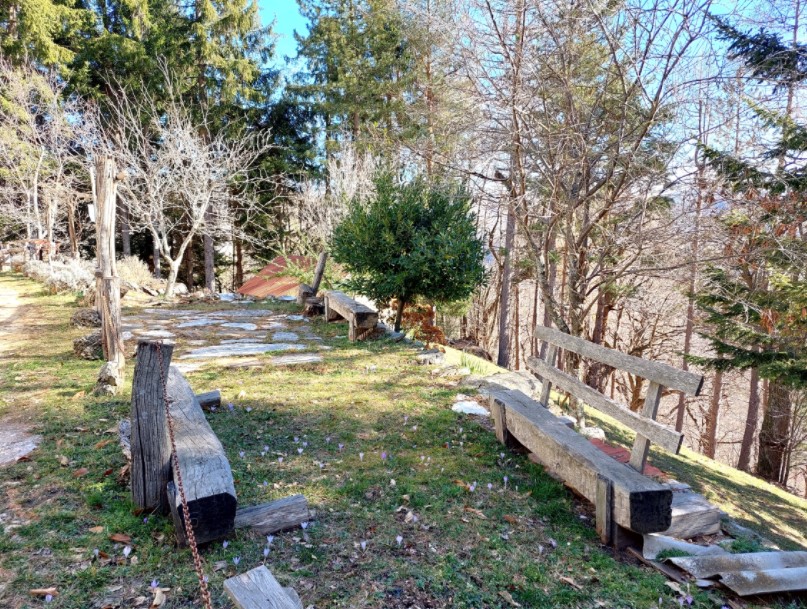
[168,366,236,544]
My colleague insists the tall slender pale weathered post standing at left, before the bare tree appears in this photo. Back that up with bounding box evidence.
[95,157,125,394]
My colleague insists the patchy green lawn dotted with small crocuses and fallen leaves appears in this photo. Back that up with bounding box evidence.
[0,274,805,609]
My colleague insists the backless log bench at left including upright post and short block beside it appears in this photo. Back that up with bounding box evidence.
[131,341,311,545]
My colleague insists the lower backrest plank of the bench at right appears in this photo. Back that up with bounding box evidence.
[527,357,684,454]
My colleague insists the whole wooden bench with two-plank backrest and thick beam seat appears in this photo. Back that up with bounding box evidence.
[490,326,703,545]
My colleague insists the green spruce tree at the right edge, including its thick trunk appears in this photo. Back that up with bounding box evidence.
[695,21,807,484]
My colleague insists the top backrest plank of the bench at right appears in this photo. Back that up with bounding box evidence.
[535,326,703,395]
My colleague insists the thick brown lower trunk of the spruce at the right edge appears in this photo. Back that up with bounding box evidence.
[757,379,791,484]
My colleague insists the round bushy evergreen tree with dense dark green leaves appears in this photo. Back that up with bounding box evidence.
[331,173,485,331]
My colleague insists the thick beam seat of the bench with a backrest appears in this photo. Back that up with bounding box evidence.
[490,390,672,533]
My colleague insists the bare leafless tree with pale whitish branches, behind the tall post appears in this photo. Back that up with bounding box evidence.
[106,75,269,297]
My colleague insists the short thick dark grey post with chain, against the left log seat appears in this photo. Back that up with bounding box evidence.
[131,340,174,514]
